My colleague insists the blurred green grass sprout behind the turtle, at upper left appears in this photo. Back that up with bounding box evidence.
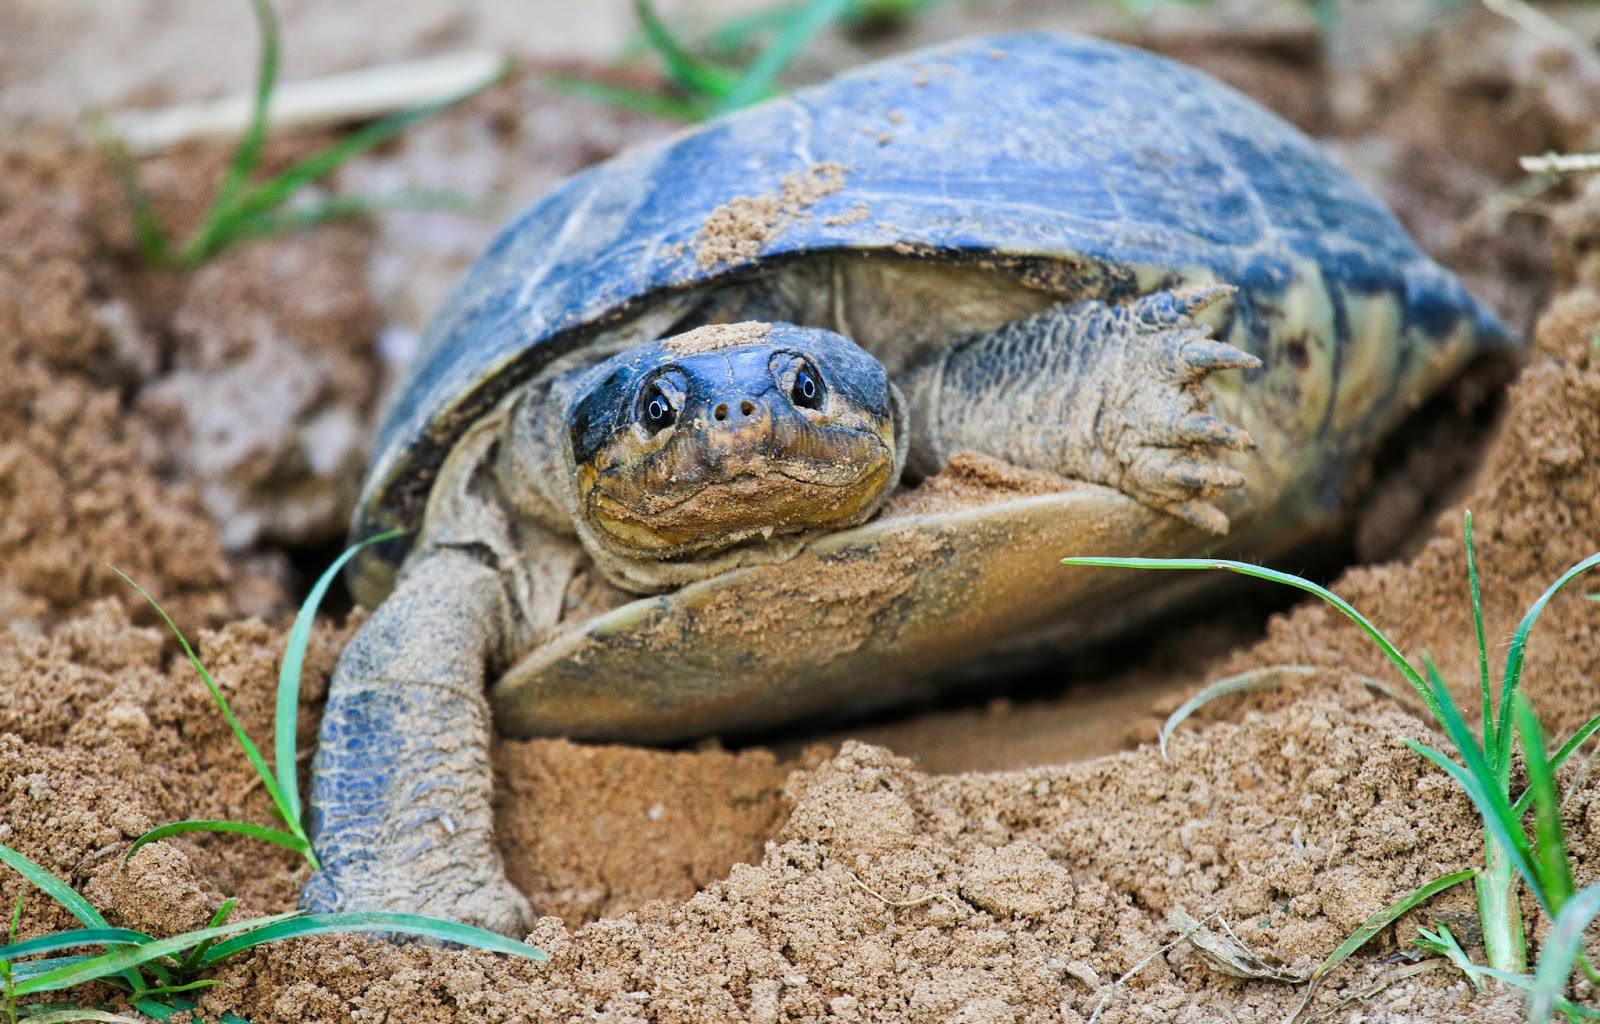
[99,0,498,269]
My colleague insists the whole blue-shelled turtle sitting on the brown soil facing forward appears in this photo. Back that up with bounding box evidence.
[302,32,1522,934]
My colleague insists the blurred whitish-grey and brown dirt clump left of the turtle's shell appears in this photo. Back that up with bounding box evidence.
[139,226,381,550]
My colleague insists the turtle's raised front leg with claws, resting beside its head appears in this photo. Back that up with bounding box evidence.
[899,285,1261,534]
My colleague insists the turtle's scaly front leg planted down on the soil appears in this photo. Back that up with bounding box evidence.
[301,549,533,938]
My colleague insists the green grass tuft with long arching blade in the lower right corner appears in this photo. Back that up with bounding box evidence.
[1062,512,1600,1021]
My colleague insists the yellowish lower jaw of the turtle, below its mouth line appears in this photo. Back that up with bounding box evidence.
[579,453,894,558]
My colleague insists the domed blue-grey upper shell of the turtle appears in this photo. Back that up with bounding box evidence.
[355,34,1506,588]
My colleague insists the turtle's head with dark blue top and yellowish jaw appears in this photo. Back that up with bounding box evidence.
[566,322,906,562]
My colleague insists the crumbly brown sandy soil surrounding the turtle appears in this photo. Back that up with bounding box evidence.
[0,2,1600,1024]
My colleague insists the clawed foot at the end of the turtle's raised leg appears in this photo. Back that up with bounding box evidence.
[1094,286,1261,534]
